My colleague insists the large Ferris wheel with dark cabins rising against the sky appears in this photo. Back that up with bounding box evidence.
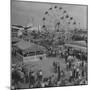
[42,5,80,31]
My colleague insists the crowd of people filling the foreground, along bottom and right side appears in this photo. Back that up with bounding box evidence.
[12,48,87,88]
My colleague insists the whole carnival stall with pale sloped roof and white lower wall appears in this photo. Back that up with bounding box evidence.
[16,40,46,62]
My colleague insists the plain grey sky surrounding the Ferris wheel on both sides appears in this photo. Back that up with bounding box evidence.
[11,0,87,29]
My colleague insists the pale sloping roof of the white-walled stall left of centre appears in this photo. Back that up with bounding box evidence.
[16,40,46,52]
